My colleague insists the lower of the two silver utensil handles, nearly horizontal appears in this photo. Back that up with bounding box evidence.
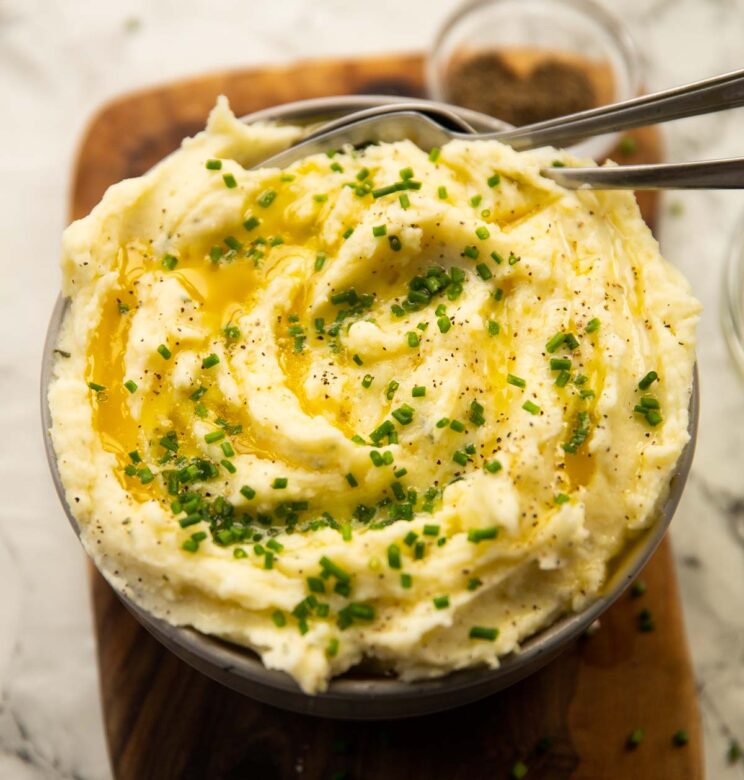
[541,157,744,190]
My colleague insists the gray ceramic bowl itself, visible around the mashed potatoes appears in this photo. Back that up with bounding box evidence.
[41,96,698,720]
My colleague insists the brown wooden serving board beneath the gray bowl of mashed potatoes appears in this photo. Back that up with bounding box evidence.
[72,56,703,780]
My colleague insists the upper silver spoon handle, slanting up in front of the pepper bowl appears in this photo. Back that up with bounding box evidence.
[488,69,744,151]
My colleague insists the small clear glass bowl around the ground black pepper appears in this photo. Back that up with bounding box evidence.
[426,0,641,159]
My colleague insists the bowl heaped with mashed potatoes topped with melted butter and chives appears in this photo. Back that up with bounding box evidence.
[42,94,700,718]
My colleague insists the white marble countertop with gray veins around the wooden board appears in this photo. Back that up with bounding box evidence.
[0,0,744,780]
